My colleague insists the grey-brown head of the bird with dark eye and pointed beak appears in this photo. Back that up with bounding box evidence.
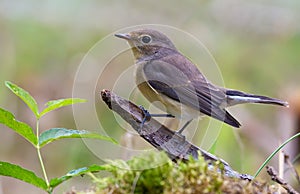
[115,29,176,59]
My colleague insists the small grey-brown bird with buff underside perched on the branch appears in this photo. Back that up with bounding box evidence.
[115,29,288,133]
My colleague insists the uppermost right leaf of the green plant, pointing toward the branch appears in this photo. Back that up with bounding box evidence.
[40,98,87,117]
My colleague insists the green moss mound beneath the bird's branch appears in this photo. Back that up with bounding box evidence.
[70,152,284,194]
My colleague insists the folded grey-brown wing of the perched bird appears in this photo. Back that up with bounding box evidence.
[143,53,240,127]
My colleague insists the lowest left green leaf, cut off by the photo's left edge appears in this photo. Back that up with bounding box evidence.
[0,161,48,191]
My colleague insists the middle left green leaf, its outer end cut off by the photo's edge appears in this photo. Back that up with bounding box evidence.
[0,108,37,146]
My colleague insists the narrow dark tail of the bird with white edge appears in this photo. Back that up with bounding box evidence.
[226,90,289,107]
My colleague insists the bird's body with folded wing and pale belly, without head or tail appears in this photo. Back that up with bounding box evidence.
[136,48,240,127]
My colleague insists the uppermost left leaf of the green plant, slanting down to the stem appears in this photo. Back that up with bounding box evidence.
[5,81,39,118]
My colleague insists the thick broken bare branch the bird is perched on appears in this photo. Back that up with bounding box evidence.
[101,90,253,180]
